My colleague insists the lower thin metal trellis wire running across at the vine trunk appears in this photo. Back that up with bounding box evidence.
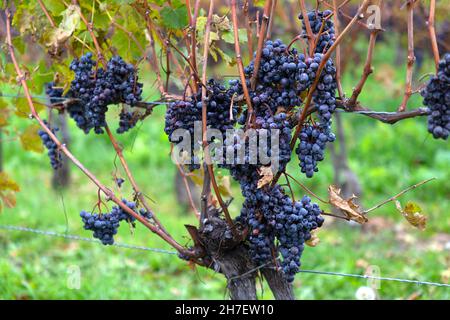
[0,225,450,288]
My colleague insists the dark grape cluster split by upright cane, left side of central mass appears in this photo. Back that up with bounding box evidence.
[164,80,237,171]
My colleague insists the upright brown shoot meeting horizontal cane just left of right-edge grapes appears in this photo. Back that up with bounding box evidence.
[398,0,416,112]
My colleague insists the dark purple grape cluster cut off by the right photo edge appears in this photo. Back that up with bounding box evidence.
[422,53,450,140]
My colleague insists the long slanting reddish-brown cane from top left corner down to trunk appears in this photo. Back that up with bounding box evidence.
[5,8,192,256]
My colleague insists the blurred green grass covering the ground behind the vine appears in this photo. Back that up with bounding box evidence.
[0,39,450,299]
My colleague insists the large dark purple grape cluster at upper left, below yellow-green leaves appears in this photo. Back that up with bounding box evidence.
[67,52,142,134]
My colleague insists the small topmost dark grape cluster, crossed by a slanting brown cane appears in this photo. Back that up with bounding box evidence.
[298,10,335,53]
